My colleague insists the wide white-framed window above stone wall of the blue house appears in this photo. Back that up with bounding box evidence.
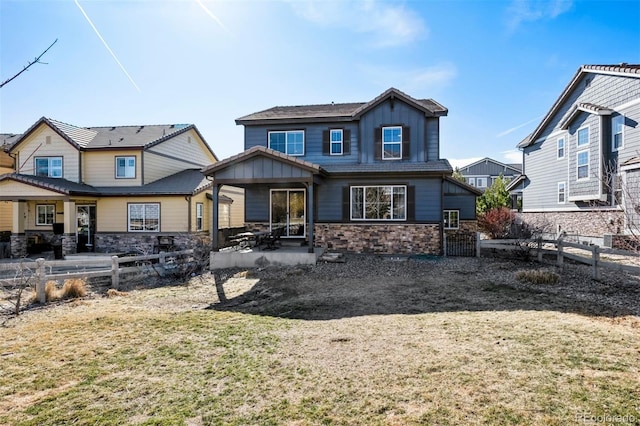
[351,185,407,220]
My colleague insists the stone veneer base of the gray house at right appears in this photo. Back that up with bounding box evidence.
[516,210,624,238]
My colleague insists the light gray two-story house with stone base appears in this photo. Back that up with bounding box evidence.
[513,64,640,240]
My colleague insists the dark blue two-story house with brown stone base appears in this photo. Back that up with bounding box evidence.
[204,88,480,254]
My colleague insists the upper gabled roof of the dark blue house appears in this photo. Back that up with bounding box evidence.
[236,87,448,125]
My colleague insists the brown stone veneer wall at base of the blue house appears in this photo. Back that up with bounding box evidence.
[315,223,442,255]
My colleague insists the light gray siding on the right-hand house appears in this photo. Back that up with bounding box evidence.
[523,72,640,212]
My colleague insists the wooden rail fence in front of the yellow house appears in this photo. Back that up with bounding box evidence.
[0,249,194,303]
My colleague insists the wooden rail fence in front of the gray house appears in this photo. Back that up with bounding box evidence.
[480,238,640,280]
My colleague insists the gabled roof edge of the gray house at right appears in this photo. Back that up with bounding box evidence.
[518,63,640,148]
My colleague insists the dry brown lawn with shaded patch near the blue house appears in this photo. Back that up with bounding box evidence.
[0,256,640,425]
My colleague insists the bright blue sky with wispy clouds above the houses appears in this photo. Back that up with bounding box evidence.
[0,0,640,165]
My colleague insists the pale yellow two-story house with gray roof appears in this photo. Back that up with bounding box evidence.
[0,118,244,257]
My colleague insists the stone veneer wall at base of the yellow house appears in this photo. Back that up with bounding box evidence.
[94,232,211,253]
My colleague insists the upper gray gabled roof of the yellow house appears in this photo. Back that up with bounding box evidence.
[10,117,218,160]
